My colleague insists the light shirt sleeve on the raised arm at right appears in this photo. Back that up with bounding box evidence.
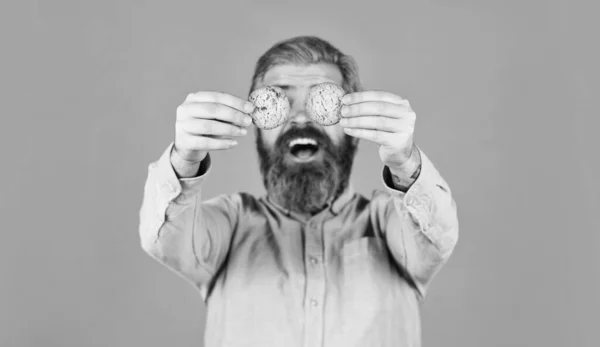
[378,149,458,297]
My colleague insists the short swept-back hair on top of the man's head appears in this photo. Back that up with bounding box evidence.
[249,36,362,94]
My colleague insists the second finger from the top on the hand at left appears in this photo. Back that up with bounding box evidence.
[177,102,252,127]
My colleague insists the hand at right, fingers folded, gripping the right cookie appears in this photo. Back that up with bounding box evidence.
[340,91,417,170]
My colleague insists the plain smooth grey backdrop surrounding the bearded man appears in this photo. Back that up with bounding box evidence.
[0,0,600,347]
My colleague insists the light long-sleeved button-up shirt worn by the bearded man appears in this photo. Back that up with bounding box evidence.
[139,144,458,347]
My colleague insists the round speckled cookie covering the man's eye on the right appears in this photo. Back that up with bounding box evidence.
[306,82,346,125]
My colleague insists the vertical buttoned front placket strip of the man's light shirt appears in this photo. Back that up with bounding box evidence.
[304,220,325,347]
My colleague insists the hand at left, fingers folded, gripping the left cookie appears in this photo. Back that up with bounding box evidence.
[173,91,254,164]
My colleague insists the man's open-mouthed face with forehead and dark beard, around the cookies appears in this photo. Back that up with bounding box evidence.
[256,64,357,214]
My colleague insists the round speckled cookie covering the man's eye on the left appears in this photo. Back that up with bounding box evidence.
[248,86,290,129]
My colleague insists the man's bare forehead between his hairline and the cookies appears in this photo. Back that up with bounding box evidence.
[262,63,343,86]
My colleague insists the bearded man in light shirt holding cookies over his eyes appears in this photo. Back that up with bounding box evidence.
[139,36,458,347]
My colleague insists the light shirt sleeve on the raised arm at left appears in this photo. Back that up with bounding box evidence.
[139,143,241,295]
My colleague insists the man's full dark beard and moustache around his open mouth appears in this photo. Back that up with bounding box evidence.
[256,125,357,215]
